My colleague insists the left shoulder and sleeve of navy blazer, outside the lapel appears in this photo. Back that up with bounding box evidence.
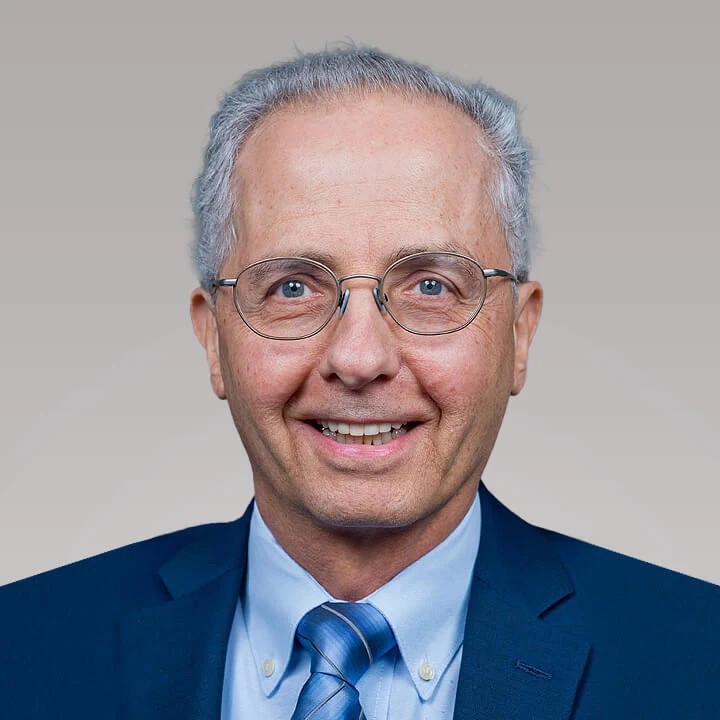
[0,521,250,718]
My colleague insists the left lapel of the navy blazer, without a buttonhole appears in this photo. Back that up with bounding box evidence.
[120,506,252,720]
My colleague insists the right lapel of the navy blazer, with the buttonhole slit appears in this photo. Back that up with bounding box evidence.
[454,486,590,720]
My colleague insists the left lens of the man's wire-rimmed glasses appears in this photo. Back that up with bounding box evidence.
[235,258,337,340]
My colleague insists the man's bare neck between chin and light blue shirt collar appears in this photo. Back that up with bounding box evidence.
[256,492,475,601]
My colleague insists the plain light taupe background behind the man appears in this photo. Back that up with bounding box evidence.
[0,0,720,582]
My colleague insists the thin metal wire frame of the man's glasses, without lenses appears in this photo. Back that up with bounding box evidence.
[210,251,520,340]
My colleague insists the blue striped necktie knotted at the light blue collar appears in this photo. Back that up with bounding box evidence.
[291,602,395,720]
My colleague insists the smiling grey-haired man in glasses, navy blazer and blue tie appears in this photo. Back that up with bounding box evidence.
[0,50,720,720]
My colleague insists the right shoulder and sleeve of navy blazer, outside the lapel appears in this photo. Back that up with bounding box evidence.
[542,531,720,719]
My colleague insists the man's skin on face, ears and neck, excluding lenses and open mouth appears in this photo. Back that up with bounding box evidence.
[191,93,542,600]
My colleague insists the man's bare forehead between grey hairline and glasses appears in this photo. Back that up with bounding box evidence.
[228,93,504,270]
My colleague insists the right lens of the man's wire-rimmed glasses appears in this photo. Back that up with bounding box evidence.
[383,253,486,335]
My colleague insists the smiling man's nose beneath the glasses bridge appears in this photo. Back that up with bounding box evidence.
[320,278,400,390]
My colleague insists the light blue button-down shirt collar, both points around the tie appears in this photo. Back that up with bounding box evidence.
[243,496,481,700]
